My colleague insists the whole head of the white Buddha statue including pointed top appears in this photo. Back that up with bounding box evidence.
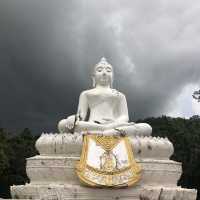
[92,57,113,87]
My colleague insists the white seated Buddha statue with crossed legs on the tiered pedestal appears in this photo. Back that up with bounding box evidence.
[58,58,152,136]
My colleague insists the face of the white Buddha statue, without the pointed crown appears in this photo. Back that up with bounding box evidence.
[94,65,113,86]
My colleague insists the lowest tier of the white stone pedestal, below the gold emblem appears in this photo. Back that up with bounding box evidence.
[11,184,196,200]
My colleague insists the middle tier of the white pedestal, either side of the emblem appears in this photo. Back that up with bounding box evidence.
[26,156,182,187]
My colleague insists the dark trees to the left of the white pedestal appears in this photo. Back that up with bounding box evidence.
[0,129,38,198]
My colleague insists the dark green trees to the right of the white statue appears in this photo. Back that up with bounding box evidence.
[140,116,200,200]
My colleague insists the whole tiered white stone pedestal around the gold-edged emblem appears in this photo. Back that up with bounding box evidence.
[11,134,196,200]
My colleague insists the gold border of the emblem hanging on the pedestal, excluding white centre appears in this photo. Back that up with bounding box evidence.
[76,135,141,187]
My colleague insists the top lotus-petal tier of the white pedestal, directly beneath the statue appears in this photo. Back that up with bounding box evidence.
[35,133,174,160]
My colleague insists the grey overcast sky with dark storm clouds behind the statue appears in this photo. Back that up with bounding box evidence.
[0,0,200,133]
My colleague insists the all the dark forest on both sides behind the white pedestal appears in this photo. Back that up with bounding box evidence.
[0,116,200,200]
